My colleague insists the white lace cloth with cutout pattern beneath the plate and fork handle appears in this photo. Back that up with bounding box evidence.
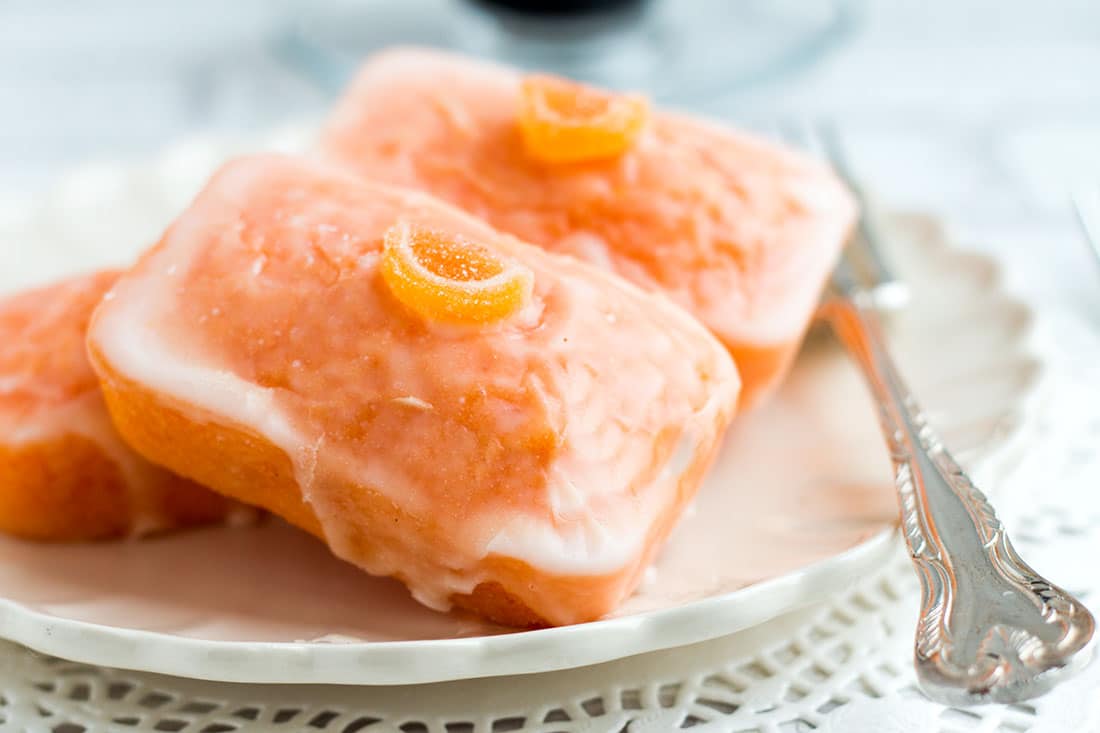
[0,314,1100,733]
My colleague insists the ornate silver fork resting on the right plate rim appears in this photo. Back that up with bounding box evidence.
[780,124,1096,705]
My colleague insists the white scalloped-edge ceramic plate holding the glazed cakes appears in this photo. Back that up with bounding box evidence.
[0,129,1038,685]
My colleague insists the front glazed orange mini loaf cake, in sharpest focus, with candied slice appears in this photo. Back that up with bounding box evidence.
[88,155,739,626]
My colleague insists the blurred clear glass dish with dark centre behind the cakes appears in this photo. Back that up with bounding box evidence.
[276,0,859,104]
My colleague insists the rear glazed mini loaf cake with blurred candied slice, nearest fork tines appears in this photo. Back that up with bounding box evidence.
[320,50,855,405]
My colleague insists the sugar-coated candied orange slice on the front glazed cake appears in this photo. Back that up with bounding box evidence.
[382,222,534,324]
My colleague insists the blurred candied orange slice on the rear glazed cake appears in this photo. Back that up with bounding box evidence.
[519,75,649,163]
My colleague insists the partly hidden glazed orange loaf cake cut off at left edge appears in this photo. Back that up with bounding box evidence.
[0,272,235,540]
